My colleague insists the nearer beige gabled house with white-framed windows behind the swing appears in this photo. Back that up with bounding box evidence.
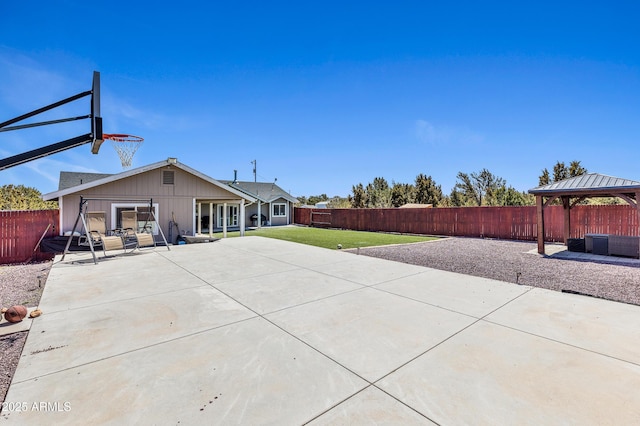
[42,158,258,242]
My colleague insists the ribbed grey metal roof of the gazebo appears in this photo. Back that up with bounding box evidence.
[529,173,640,195]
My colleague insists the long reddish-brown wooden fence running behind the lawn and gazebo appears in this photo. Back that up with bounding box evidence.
[294,205,639,242]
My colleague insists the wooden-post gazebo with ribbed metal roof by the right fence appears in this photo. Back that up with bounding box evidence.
[529,173,640,254]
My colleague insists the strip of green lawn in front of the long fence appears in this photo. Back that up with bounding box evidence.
[220,226,437,249]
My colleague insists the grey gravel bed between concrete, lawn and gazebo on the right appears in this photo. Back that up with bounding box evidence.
[360,238,640,305]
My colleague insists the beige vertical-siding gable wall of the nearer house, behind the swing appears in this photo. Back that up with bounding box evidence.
[60,165,241,239]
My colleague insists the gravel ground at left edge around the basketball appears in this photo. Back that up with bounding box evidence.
[0,262,52,411]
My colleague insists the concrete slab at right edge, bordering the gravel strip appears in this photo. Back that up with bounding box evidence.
[486,288,640,365]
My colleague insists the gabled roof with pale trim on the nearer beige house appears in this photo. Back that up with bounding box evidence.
[42,158,256,201]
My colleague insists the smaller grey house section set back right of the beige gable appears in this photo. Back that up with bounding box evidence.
[221,180,298,226]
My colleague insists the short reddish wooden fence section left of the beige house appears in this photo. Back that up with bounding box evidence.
[0,210,60,264]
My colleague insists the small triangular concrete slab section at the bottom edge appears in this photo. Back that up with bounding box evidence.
[309,386,435,425]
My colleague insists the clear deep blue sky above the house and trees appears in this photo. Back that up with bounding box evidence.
[0,1,640,196]
